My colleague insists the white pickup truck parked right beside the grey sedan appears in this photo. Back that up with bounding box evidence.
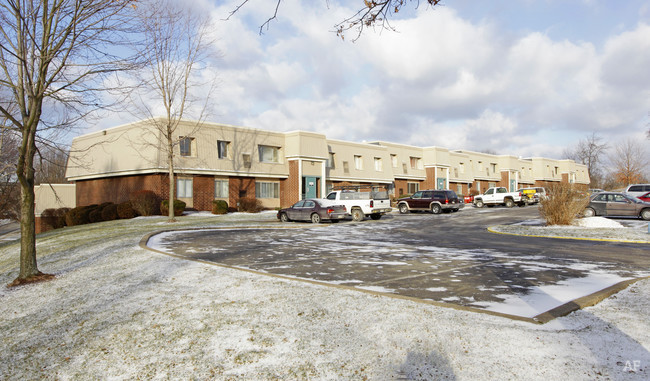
[325,189,393,221]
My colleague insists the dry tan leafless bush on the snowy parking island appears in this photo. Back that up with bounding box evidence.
[539,183,589,225]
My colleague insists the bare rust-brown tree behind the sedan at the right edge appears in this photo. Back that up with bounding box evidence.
[610,139,647,186]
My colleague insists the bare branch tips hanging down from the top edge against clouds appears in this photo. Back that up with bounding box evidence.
[228,0,441,41]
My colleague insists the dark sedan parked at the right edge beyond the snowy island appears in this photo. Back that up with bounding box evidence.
[582,192,650,220]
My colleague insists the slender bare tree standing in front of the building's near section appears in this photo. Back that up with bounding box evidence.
[134,0,217,222]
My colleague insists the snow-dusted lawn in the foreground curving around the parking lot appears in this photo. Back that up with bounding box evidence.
[0,214,650,380]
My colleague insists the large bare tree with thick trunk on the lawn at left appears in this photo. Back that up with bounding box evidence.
[0,0,133,284]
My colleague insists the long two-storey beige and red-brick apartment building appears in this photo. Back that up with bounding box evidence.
[66,121,589,210]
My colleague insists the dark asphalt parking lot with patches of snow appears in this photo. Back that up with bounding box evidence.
[148,207,650,319]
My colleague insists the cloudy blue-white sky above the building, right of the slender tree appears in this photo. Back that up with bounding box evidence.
[95,0,650,158]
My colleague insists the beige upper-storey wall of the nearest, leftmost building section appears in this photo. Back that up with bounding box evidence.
[66,122,289,180]
